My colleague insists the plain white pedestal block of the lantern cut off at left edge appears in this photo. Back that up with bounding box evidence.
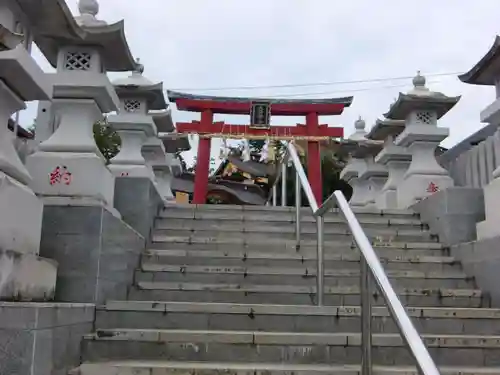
[0,172,43,254]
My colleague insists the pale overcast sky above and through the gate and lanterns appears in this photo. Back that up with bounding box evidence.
[21,0,500,167]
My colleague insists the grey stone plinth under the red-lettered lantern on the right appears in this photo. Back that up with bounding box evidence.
[411,187,484,246]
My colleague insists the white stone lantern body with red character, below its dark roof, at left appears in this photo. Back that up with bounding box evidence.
[26,45,119,216]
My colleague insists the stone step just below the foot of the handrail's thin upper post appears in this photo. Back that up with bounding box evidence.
[142,251,461,272]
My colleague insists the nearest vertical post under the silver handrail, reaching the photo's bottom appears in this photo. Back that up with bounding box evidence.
[360,256,372,375]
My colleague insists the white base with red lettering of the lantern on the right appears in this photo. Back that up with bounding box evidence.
[398,174,454,208]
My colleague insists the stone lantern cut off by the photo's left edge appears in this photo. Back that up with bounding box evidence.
[0,1,57,301]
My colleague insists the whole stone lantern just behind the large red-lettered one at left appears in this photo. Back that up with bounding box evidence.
[108,65,168,182]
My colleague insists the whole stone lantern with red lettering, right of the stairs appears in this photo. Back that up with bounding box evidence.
[385,73,460,208]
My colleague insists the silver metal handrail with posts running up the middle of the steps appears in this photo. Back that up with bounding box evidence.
[287,142,440,375]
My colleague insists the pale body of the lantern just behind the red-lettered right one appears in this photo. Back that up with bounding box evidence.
[367,119,411,209]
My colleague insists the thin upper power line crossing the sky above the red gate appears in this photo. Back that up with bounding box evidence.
[172,72,463,91]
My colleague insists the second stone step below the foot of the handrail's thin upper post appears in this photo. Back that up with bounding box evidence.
[135,263,474,289]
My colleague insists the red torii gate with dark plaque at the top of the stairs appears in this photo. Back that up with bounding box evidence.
[168,91,353,204]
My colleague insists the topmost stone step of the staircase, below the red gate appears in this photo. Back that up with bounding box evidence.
[159,205,420,223]
